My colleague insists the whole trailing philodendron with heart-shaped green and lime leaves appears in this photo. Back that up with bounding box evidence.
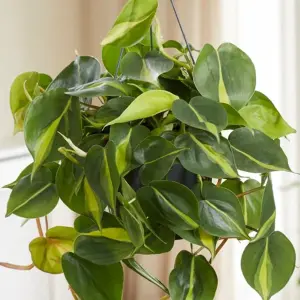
[2,0,295,300]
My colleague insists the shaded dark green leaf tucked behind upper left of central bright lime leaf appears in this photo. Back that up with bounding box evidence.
[88,97,134,128]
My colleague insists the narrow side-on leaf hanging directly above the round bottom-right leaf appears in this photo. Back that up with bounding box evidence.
[253,178,276,241]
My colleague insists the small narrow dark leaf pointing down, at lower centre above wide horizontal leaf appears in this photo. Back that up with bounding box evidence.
[120,206,145,248]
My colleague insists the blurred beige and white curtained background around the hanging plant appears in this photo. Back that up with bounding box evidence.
[0,0,300,300]
